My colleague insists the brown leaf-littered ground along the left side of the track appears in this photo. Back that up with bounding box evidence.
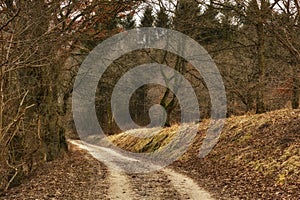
[0,146,109,200]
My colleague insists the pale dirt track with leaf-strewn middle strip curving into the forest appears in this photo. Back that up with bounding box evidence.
[70,140,213,200]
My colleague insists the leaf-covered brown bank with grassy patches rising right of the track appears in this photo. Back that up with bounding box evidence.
[111,110,300,199]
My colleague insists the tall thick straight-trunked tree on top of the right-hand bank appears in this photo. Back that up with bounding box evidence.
[207,0,271,113]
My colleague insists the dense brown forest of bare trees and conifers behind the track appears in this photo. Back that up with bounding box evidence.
[0,0,300,194]
